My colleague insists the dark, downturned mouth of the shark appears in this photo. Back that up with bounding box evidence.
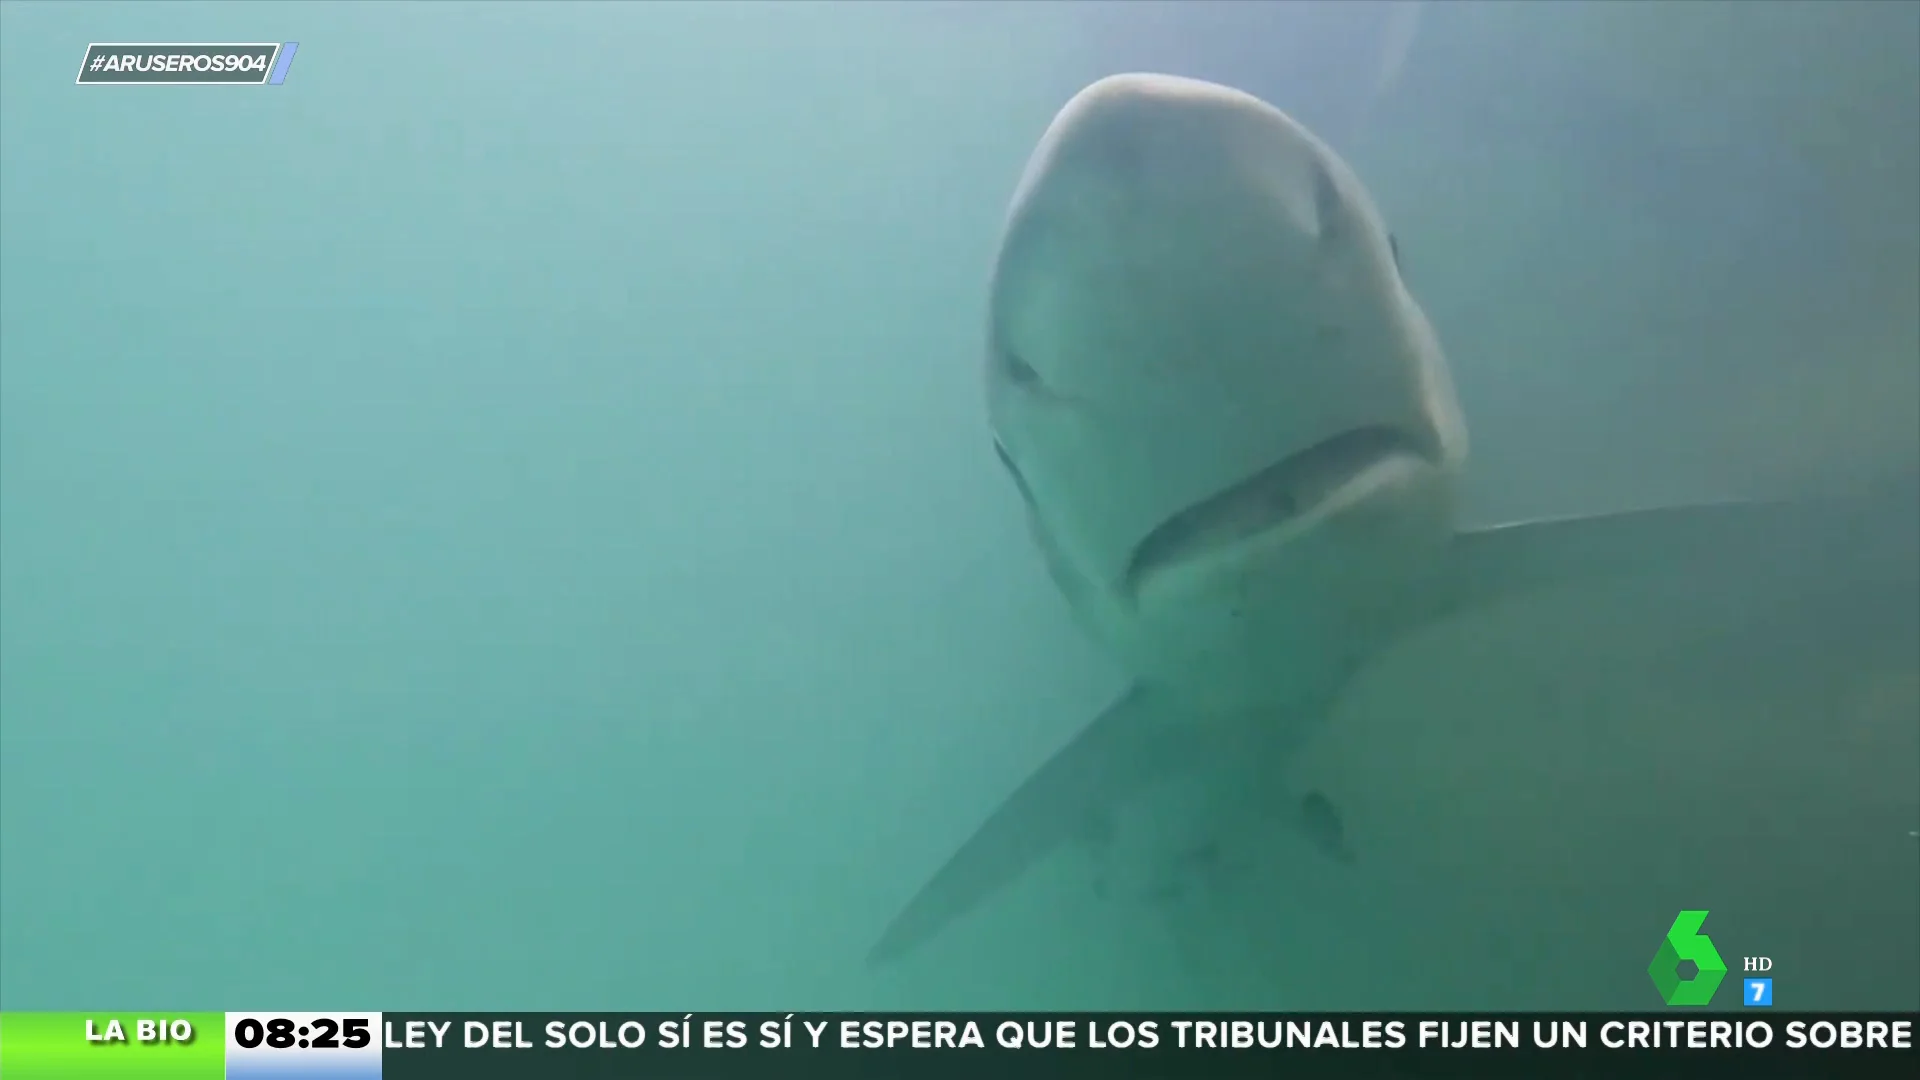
[1123,425,1427,596]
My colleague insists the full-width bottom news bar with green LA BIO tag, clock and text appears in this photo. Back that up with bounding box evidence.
[0,1013,1920,1080]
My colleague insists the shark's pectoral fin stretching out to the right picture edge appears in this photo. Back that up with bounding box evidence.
[1432,484,1920,617]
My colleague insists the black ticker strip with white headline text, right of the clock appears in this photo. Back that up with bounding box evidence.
[382,1011,1920,1080]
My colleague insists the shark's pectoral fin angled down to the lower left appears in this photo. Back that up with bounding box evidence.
[868,686,1194,965]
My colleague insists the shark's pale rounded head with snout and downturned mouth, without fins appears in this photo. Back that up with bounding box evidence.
[987,75,1467,694]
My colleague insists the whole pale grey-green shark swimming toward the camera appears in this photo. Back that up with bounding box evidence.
[868,73,1920,999]
